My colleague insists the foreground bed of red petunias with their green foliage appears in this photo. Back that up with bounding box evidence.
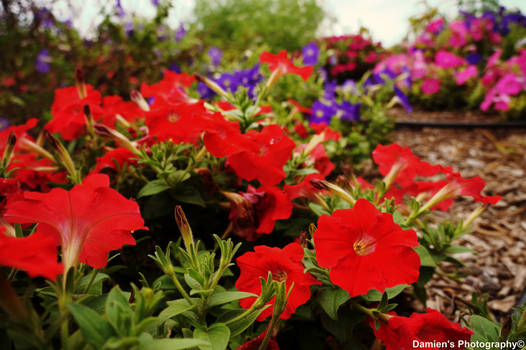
[0,47,525,349]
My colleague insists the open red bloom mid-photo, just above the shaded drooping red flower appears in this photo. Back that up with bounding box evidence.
[227,125,296,186]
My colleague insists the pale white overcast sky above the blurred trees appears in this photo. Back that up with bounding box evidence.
[43,0,526,47]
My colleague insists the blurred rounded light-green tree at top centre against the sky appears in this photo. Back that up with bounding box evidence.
[192,0,326,51]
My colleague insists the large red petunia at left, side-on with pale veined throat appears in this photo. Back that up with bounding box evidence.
[4,174,145,269]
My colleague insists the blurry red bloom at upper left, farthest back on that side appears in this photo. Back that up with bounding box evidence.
[45,84,102,141]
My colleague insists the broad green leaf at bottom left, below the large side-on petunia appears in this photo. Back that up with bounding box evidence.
[67,303,115,349]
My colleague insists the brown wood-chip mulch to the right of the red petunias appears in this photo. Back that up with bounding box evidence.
[392,113,526,321]
